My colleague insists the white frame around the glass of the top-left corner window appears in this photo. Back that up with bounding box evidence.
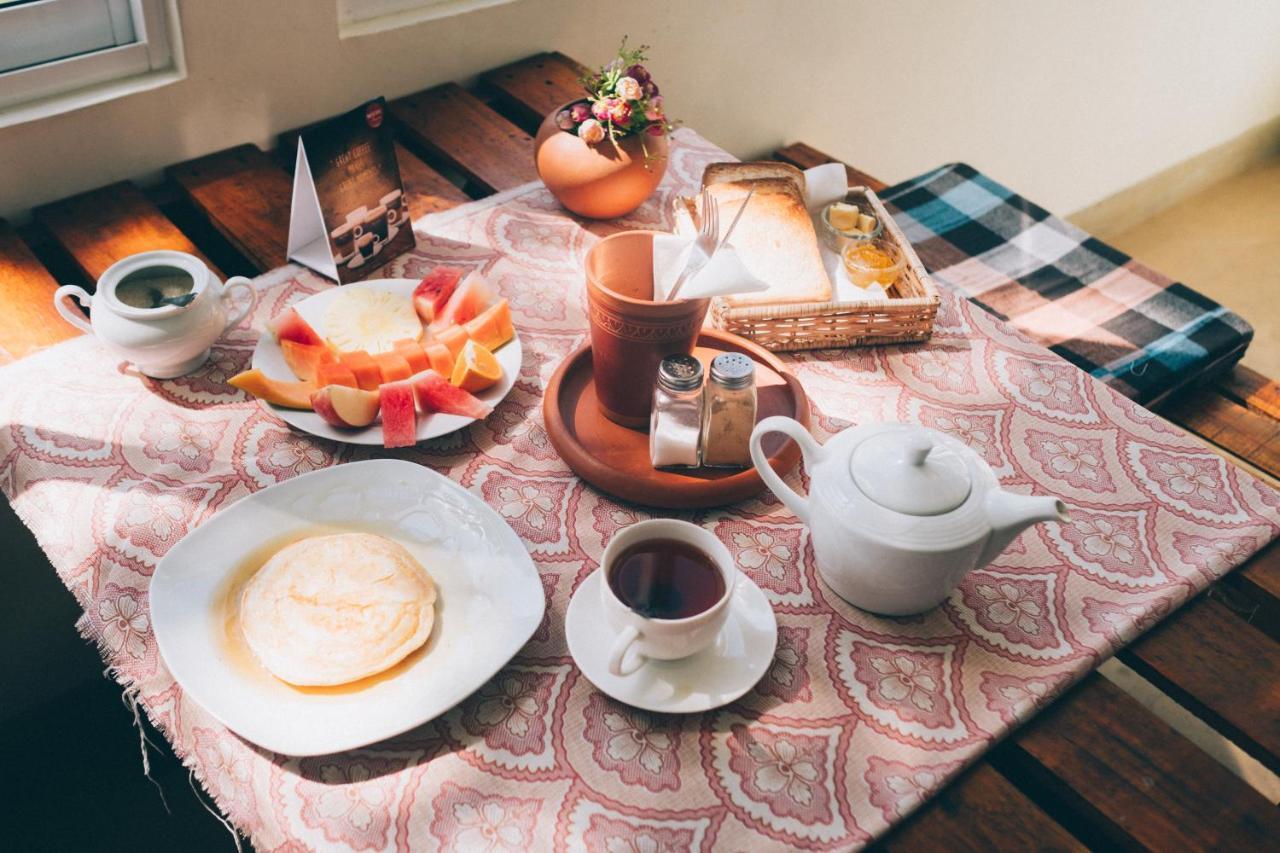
[0,0,187,127]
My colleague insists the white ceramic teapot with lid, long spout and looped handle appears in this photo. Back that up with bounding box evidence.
[751,418,1068,616]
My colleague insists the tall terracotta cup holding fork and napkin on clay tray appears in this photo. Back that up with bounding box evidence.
[586,231,710,429]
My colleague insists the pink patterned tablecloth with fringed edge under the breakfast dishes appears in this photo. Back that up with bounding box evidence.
[0,131,1280,850]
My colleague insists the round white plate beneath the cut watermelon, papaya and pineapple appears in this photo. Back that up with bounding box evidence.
[253,278,524,447]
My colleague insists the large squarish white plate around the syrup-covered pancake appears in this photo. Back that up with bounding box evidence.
[151,460,545,756]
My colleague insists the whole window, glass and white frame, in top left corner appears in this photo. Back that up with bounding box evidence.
[0,0,186,127]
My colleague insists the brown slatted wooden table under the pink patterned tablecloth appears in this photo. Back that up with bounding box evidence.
[0,54,1280,849]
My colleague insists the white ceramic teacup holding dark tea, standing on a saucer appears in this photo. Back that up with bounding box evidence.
[600,519,737,676]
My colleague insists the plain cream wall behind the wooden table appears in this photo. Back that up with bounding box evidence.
[0,0,1280,216]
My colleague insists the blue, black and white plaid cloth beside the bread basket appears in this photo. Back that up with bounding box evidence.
[881,163,1253,405]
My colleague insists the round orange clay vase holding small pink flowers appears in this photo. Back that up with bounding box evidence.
[534,101,667,219]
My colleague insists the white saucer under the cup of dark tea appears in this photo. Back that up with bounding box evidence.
[564,569,778,713]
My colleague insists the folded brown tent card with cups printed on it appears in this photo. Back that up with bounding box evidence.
[288,97,415,284]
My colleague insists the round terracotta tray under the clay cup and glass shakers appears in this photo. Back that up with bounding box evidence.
[543,329,809,508]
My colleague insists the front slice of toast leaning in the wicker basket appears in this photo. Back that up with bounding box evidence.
[695,163,833,307]
